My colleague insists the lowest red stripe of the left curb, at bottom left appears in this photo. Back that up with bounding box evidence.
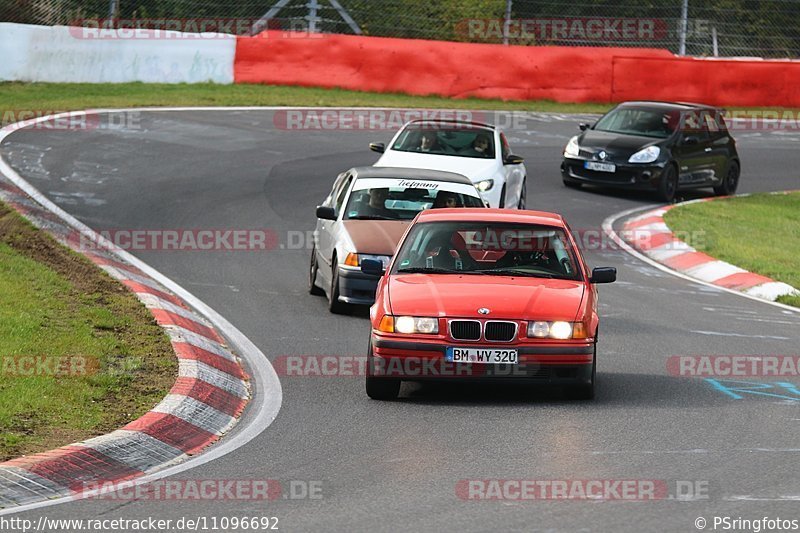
[3,446,144,491]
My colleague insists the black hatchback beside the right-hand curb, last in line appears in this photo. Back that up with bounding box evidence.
[561,102,741,202]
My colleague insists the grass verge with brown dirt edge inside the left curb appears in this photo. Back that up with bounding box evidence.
[0,203,177,460]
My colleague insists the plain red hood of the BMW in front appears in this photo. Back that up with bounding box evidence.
[389,274,585,321]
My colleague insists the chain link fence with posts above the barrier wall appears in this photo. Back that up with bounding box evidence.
[0,0,800,58]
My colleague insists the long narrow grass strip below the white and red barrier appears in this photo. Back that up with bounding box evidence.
[0,82,611,113]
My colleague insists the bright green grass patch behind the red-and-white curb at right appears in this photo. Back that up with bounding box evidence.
[664,192,800,307]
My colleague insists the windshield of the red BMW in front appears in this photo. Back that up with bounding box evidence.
[392,222,582,280]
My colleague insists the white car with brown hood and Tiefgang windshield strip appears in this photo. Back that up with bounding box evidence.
[308,167,484,313]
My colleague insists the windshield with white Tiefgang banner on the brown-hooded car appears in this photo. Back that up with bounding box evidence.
[344,178,484,220]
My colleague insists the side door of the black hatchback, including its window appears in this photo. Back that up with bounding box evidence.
[673,111,713,185]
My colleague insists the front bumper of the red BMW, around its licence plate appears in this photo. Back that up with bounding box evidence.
[368,334,594,385]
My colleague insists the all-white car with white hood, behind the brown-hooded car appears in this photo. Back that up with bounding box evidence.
[369,119,527,209]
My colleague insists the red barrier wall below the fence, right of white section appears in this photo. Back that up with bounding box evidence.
[234,31,800,106]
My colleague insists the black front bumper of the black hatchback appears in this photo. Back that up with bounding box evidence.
[561,158,665,190]
